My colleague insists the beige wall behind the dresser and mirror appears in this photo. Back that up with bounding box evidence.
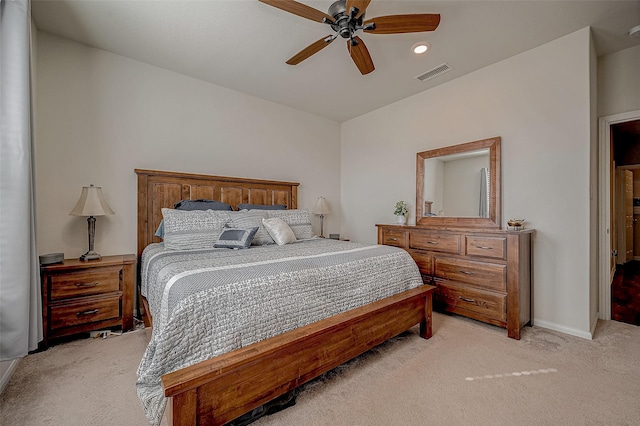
[341,28,591,337]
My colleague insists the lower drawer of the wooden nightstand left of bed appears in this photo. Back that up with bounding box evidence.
[50,295,120,330]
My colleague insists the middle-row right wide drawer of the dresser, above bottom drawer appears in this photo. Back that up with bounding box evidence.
[434,257,507,291]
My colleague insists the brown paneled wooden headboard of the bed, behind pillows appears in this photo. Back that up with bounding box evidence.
[135,169,300,256]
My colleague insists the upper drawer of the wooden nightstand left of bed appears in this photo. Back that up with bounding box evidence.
[49,266,122,300]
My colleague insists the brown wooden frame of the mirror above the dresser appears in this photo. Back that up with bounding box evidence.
[416,137,502,228]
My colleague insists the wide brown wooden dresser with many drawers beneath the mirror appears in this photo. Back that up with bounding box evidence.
[376,225,534,339]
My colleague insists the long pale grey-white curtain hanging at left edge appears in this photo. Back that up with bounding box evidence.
[0,0,42,361]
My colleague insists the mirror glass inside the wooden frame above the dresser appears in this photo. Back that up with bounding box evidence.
[422,148,491,218]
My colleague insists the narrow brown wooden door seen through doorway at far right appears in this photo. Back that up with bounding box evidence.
[616,169,633,264]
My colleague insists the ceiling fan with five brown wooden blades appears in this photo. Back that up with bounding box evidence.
[259,0,440,75]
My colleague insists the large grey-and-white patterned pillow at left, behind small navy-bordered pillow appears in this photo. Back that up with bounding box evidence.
[162,208,228,250]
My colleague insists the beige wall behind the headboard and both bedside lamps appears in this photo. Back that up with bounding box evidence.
[36,32,340,257]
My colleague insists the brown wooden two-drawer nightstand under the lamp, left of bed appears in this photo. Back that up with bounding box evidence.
[40,254,136,348]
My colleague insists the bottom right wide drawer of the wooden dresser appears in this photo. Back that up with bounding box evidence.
[435,280,507,322]
